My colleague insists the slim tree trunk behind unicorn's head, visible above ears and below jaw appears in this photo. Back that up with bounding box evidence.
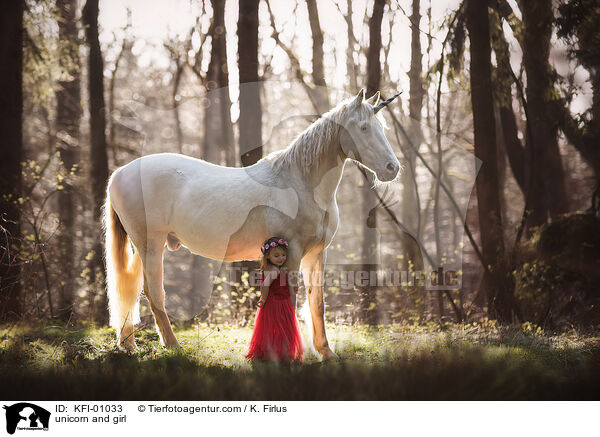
[360,0,385,325]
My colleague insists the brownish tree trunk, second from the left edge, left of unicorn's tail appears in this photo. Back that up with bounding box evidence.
[56,0,82,321]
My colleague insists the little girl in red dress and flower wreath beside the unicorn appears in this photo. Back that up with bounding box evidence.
[246,237,304,363]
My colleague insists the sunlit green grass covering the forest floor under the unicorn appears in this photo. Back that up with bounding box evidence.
[0,321,600,400]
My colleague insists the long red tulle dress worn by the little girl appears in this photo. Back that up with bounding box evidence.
[246,270,304,363]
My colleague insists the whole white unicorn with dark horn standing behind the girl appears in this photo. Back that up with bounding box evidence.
[104,90,400,359]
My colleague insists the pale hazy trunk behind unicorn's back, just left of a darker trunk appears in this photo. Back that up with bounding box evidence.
[204,0,235,166]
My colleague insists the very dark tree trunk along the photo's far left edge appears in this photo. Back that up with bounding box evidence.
[0,0,24,321]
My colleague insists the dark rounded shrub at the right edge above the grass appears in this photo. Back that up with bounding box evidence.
[513,214,600,328]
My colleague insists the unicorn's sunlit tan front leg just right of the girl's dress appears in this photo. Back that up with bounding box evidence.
[302,252,339,360]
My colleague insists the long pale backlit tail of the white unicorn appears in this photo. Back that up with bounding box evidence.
[103,183,144,334]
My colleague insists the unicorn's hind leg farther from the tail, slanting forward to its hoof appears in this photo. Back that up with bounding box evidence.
[143,240,181,347]
